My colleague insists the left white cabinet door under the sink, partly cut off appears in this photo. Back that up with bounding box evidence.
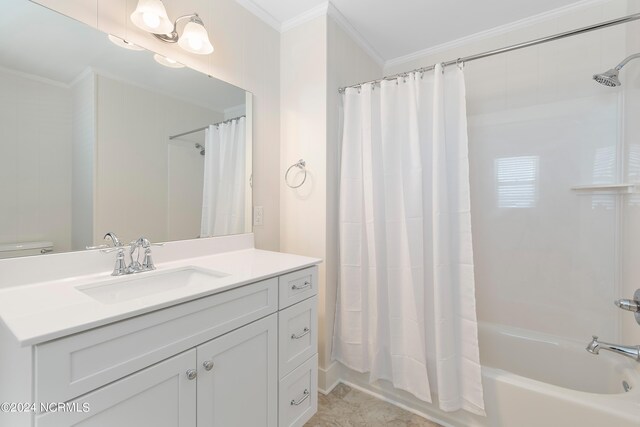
[36,349,196,427]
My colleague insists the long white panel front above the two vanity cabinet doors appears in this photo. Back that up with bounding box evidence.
[35,278,278,402]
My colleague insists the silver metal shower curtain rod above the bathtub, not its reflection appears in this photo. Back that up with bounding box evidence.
[338,13,640,93]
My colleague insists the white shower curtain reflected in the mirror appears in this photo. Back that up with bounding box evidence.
[200,117,247,237]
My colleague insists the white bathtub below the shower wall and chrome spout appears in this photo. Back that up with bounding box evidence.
[478,323,640,427]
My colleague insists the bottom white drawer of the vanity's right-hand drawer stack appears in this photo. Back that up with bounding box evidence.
[279,354,318,427]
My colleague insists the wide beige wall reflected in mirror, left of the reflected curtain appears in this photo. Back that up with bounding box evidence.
[94,75,223,244]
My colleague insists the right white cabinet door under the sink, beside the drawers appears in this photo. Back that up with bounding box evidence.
[197,314,278,427]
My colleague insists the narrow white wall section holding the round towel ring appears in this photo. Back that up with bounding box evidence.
[280,16,327,366]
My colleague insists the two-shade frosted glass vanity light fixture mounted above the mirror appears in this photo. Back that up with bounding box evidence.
[131,0,213,55]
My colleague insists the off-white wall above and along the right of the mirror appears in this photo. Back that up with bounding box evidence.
[31,0,281,250]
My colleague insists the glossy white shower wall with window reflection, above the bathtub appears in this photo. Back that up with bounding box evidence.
[385,0,640,341]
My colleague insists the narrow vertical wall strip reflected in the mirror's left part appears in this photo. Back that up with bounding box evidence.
[71,70,96,250]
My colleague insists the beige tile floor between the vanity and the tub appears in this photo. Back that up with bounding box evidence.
[305,384,440,427]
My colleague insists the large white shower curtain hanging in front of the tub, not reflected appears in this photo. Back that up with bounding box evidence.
[333,65,484,414]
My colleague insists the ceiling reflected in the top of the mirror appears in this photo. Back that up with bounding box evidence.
[0,0,245,112]
